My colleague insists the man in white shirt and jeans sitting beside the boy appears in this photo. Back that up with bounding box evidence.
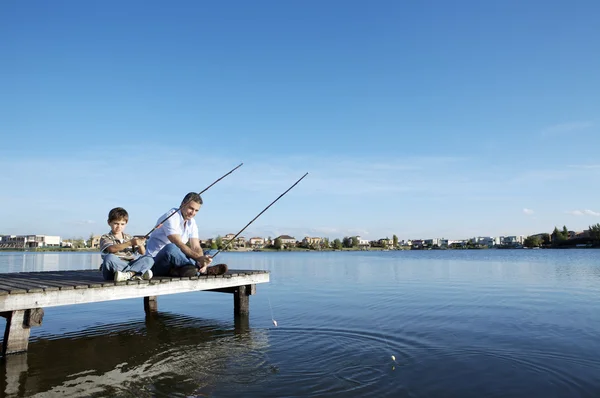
[147,192,227,277]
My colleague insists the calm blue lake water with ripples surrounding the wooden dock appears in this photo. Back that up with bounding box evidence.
[0,250,600,398]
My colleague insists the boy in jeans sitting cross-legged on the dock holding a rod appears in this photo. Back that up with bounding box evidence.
[100,207,154,282]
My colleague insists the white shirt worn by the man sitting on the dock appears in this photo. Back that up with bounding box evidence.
[146,209,198,257]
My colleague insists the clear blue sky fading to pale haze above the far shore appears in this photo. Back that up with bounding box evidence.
[0,0,600,239]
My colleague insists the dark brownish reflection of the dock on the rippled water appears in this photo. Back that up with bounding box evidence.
[0,313,270,397]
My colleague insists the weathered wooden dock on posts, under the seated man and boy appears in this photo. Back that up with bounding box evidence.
[0,269,269,355]
